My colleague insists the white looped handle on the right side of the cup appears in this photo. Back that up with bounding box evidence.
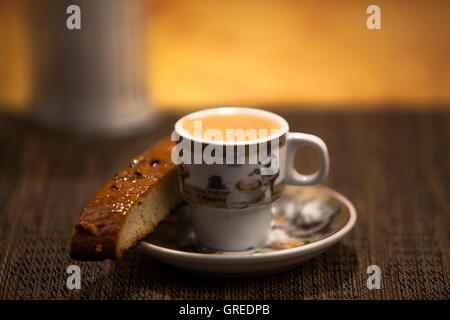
[285,132,330,186]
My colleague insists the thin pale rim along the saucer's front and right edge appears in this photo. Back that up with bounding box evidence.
[138,185,357,264]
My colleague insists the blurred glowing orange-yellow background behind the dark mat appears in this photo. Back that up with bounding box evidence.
[0,0,450,111]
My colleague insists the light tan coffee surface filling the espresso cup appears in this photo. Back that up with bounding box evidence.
[182,113,280,142]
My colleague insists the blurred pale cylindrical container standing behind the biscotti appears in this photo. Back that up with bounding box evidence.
[27,0,154,134]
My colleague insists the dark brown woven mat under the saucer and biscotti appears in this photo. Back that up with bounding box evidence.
[0,112,450,299]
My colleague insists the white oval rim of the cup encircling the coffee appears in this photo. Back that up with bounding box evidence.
[175,107,289,146]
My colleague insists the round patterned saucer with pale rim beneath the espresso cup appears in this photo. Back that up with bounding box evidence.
[139,185,356,276]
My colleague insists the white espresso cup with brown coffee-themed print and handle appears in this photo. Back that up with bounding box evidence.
[172,107,329,251]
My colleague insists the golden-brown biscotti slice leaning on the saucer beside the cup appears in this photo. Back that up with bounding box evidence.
[70,138,181,260]
